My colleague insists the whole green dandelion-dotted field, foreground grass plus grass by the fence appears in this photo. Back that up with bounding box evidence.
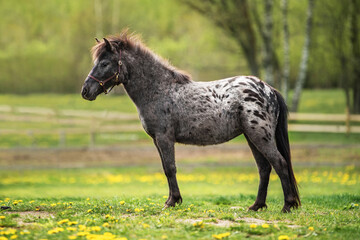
[0,90,360,240]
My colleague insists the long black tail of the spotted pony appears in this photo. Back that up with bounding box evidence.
[275,90,301,208]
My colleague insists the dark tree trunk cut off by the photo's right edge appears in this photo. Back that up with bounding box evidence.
[350,0,360,113]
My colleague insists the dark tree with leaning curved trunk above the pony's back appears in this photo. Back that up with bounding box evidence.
[179,0,259,76]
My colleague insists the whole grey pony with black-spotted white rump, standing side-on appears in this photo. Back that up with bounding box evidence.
[82,31,300,212]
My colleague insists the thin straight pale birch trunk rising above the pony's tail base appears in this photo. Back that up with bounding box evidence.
[281,0,290,102]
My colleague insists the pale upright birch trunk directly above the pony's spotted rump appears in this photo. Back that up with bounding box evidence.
[263,0,274,86]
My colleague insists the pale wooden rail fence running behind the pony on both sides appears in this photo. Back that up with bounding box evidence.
[0,105,360,146]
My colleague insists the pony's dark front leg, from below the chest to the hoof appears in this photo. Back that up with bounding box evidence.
[154,136,182,208]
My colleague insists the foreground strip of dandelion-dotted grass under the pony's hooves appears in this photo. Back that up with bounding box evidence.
[0,166,360,240]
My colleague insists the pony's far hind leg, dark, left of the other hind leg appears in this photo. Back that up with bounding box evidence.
[245,135,271,211]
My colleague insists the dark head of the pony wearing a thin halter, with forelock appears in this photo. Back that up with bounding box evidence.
[81,38,125,101]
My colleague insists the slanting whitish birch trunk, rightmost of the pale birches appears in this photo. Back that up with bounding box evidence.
[291,0,314,112]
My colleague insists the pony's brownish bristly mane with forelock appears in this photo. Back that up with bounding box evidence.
[91,29,191,83]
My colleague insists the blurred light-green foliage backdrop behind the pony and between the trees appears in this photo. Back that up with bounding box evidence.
[0,0,349,94]
